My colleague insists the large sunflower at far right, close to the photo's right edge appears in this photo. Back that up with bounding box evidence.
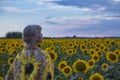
[106,52,118,63]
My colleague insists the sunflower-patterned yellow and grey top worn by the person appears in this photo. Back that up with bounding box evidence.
[5,49,54,80]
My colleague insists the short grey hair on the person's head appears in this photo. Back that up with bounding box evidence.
[23,25,42,44]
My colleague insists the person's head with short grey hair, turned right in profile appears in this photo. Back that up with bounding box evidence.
[23,25,42,44]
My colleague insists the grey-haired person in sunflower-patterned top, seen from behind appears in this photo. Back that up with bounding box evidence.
[5,25,54,80]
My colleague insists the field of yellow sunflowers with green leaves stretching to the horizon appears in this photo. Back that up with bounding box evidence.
[0,38,120,80]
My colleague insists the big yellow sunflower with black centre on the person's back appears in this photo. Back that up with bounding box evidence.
[20,58,40,80]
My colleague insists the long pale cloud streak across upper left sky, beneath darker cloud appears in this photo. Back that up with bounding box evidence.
[0,3,92,15]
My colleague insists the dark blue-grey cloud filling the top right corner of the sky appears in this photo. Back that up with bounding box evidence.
[56,0,120,14]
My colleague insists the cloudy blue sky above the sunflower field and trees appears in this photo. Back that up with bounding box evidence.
[0,0,120,37]
